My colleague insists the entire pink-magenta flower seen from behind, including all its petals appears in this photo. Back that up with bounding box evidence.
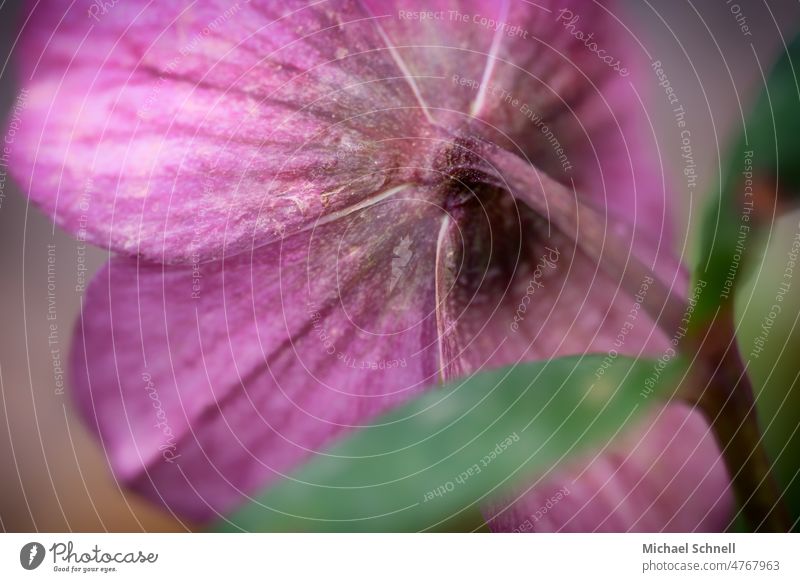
[7,0,731,531]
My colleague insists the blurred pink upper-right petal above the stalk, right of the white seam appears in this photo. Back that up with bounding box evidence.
[488,0,672,244]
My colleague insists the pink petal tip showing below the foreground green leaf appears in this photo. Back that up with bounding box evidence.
[487,404,733,532]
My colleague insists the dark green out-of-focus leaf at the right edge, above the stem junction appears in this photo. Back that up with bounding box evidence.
[689,36,800,335]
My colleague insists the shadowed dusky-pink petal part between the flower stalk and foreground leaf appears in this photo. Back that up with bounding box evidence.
[432,182,686,379]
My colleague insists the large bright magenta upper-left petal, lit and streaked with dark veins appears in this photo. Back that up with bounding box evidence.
[12,1,426,263]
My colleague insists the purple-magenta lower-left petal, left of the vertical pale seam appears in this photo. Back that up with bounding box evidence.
[73,189,444,520]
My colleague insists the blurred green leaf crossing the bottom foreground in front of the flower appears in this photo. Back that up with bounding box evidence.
[216,355,684,531]
